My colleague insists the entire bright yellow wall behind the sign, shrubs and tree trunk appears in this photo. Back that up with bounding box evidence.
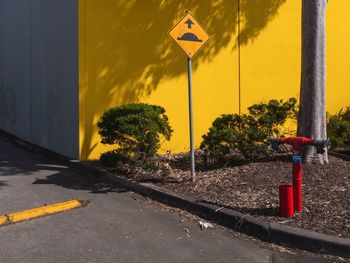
[79,0,350,159]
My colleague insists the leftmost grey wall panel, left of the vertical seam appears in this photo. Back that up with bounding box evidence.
[0,0,31,139]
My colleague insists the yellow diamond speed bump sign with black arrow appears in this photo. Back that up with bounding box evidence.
[169,12,209,59]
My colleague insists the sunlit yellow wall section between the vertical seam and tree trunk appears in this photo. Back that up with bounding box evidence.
[240,0,301,110]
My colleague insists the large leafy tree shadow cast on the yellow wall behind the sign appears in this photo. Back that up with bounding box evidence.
[80,0,286,159]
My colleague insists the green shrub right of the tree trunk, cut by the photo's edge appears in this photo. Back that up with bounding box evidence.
[327,107,350,148]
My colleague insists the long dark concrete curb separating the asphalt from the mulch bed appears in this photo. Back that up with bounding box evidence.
[0,130,350,258]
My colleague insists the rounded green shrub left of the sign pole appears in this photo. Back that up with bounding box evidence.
[97,103,173,166]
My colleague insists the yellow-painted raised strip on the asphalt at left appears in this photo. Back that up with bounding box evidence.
[0,200,83,225]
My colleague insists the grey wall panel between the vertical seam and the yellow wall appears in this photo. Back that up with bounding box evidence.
[31,0,79,158]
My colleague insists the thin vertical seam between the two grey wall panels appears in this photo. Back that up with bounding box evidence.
[28,0,33,141]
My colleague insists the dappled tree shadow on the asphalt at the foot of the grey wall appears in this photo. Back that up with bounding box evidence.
[0,137,127,194]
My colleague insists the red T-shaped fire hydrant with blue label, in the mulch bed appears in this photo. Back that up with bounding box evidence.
[269,137,329,218]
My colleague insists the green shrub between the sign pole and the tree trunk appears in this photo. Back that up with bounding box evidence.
[200,98,297,162]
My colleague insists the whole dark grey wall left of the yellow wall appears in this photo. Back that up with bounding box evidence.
[0,0,79,158]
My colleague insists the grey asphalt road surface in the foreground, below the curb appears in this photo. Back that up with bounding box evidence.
[0,137,344,263]
